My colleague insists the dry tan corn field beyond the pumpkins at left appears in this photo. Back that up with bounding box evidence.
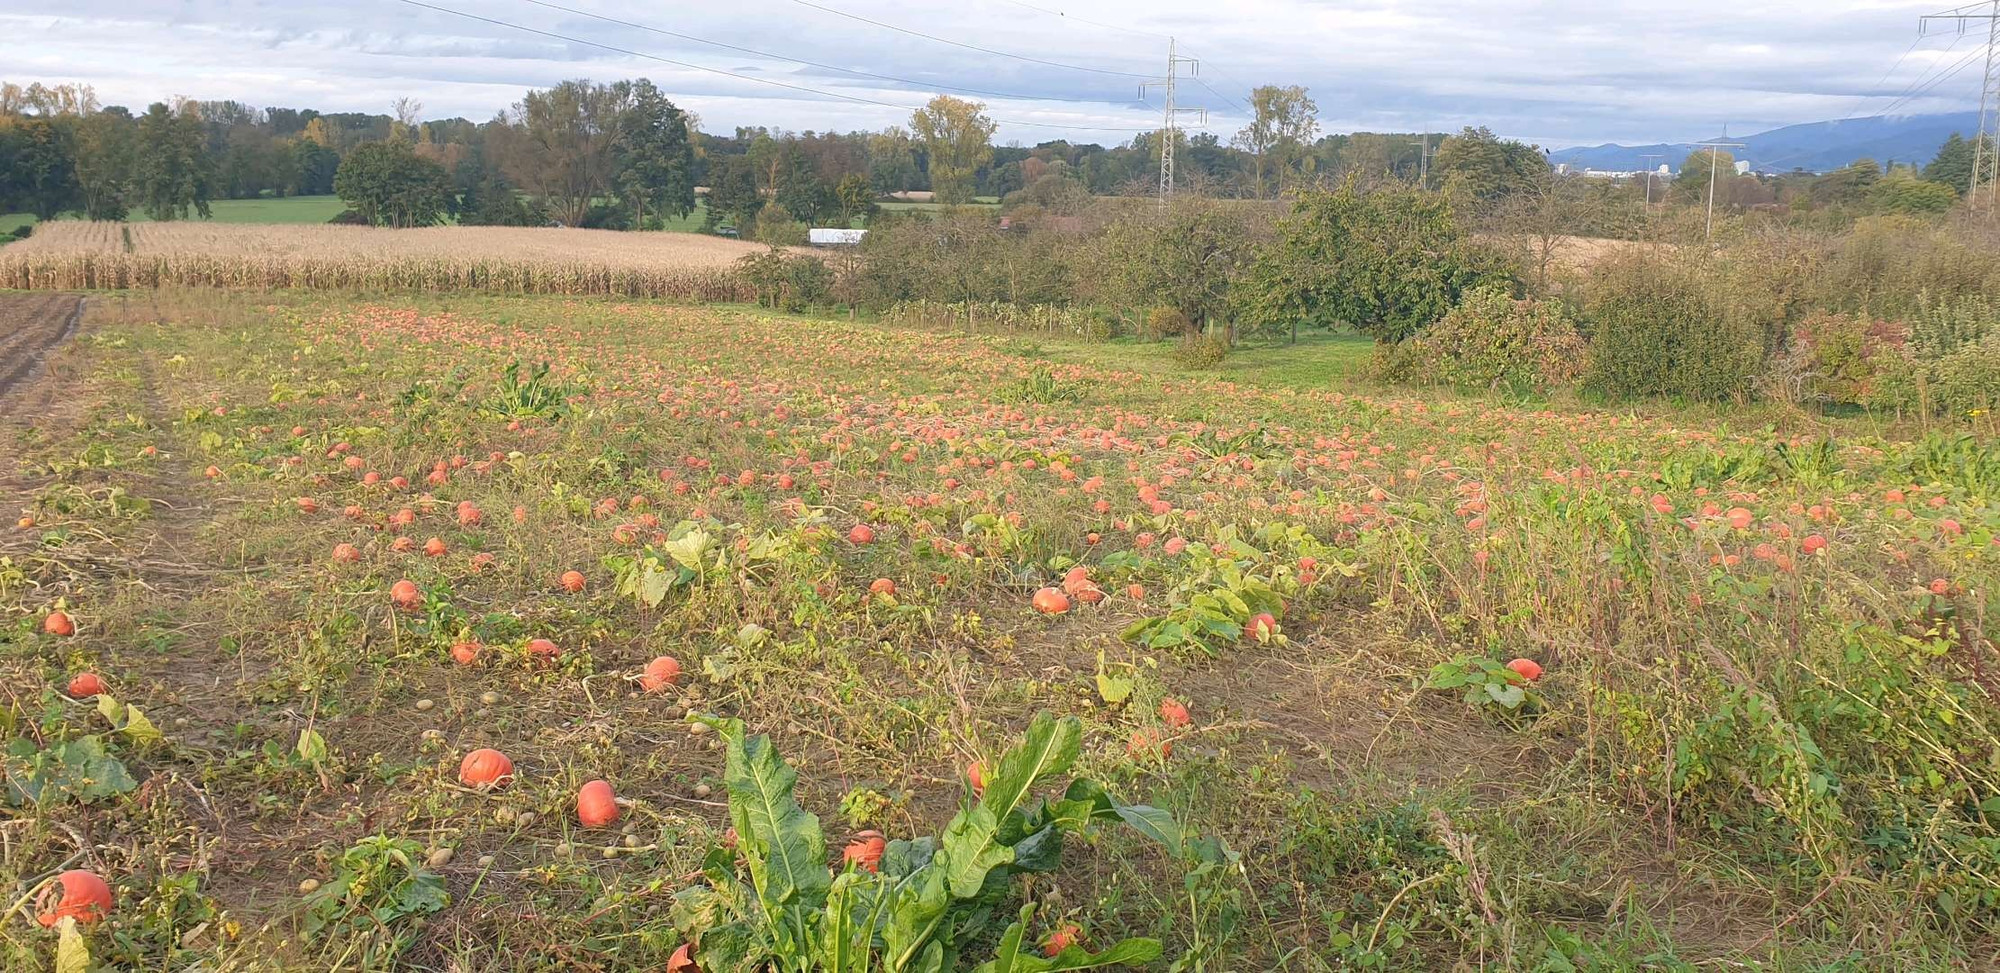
[0,222,762,300]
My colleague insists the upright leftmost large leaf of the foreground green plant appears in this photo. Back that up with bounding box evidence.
[698,717,832,919]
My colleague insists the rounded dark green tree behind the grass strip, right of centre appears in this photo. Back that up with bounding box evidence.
[1238,178,1506,342]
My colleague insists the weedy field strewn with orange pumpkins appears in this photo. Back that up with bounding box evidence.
[0,284,2000,973]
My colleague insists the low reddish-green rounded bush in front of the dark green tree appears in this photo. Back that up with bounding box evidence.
[1382,286,1588,394]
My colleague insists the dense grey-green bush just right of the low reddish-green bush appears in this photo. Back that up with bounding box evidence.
[1586,256,1782,400]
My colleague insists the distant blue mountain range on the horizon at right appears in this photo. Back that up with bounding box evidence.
[1548,112,1980,172]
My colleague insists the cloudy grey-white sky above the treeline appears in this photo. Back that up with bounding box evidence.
[0,0,1984,146]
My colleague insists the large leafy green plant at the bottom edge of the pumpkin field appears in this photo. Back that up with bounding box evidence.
[674,713,1164,973]
